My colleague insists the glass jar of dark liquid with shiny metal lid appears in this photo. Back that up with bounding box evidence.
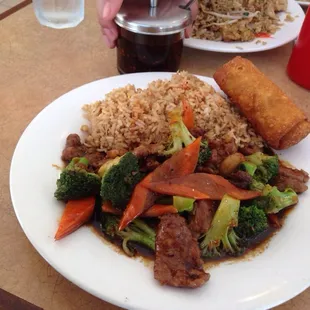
[115,0,191,74]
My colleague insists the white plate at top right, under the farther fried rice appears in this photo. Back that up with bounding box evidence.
[184,0,305,53]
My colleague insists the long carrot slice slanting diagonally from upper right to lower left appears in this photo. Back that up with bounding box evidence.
[119,138,201,230]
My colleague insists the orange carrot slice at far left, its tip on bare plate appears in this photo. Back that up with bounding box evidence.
[55,197,95,240]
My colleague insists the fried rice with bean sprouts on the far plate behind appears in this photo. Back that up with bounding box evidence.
[192,0,287,42]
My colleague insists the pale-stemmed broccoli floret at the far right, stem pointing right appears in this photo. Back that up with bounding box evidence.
[263,185,298,213]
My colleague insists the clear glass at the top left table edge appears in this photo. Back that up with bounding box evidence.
[32,0,84,29]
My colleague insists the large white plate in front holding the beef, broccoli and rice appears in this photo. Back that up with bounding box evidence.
[10,73,310,310]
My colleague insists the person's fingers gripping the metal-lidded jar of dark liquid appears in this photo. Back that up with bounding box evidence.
[97,0,198,48]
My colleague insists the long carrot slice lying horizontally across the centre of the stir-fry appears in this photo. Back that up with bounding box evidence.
[144,173,261,200]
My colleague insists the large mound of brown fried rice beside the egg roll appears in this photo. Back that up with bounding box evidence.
[82,72,263,151]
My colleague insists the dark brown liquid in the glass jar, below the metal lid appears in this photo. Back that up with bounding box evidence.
[117,28,183,74]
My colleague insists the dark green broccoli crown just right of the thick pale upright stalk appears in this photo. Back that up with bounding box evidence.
[235,205,268,239]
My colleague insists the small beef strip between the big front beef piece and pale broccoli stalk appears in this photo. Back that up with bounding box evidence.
[188,200,215,239]
